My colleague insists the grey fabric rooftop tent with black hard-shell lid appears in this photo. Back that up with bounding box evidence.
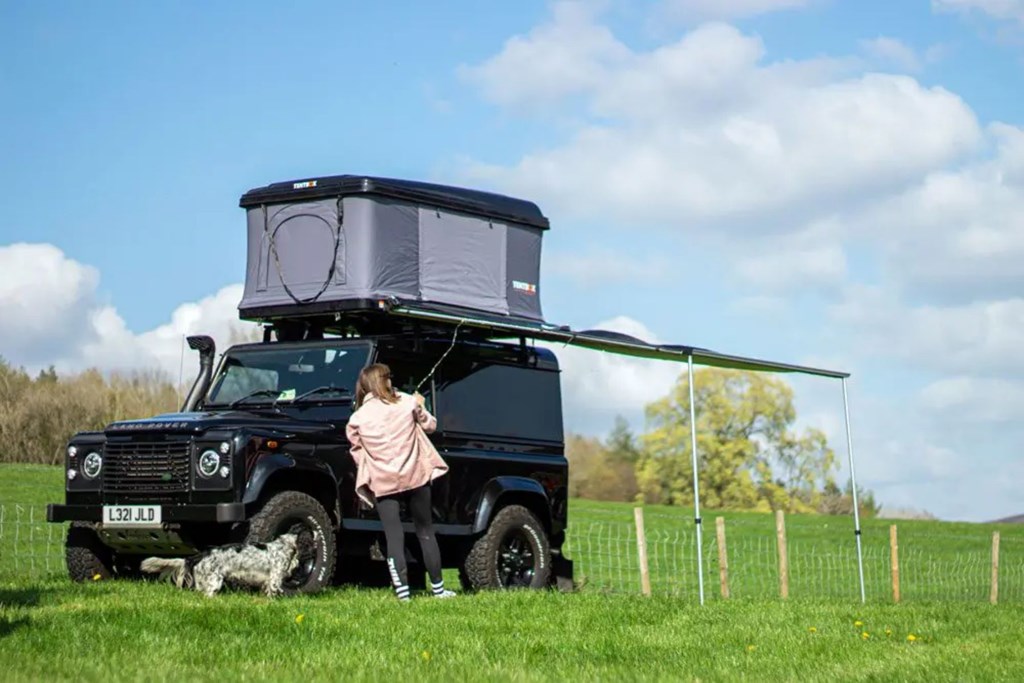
[239,175,549,321]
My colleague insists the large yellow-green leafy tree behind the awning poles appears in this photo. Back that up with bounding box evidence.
[637,369,836,511]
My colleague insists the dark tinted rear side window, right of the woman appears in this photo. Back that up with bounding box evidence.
[437,360,562,442]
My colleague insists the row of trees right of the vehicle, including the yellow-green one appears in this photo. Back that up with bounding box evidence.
[566,368,881,516]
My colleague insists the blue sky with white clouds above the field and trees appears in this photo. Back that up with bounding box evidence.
[0,0,1024,521]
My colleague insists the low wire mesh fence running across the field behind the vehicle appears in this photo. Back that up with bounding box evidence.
[0,505,1024,603]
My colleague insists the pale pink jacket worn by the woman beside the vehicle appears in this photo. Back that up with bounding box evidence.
[345,392,449,505]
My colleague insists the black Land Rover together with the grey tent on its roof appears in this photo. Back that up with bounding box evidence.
[48,176,572,592]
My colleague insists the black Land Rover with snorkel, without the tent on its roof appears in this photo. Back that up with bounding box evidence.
[48,324,571,593]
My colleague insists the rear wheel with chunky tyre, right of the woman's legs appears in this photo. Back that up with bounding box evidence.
[459,505,551,590]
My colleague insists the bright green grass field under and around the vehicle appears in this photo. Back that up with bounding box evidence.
[0,466,1024,681]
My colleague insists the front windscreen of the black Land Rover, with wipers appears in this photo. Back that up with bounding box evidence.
[206,341,370,407]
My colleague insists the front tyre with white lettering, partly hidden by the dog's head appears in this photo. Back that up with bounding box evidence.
[246,490,338,595]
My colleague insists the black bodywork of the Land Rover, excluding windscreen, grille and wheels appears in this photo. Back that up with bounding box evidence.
[48,335,568,565]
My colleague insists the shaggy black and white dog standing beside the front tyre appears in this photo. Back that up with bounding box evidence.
[141,533,299,597]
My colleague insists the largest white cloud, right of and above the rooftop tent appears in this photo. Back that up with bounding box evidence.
[464,16,980,230]
